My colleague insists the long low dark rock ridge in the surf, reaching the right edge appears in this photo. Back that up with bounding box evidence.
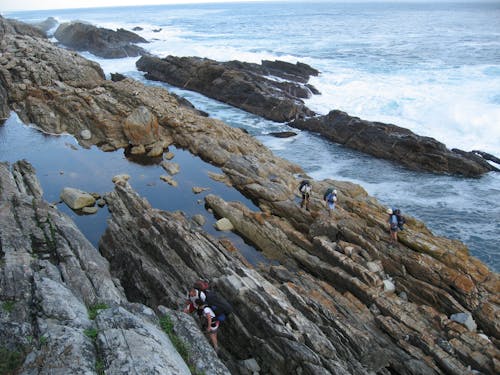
[289,110,498,177]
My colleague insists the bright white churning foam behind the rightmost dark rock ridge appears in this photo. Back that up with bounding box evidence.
[306,67,500,155]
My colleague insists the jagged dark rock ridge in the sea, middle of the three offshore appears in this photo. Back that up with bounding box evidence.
[136,56,318,122]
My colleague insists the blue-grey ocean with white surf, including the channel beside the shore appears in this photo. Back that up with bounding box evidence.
[0,1,500,272]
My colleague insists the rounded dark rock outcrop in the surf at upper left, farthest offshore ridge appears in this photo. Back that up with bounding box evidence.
[54,22,147,59]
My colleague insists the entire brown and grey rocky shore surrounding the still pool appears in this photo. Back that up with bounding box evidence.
[0,18,500,375]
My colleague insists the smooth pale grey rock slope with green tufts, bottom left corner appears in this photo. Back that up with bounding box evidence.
[0,161,227,374]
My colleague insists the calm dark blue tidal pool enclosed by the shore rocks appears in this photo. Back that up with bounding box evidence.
[0,114,270,265]
